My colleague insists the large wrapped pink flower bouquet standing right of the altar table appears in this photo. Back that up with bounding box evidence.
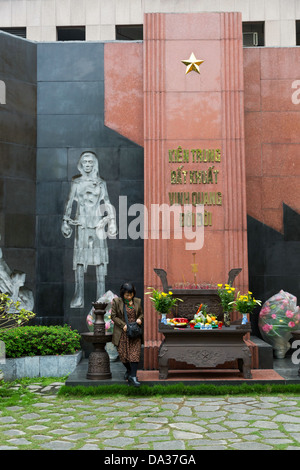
[258,290,300,358]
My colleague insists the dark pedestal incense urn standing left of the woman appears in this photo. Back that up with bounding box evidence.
[81,302,112,380]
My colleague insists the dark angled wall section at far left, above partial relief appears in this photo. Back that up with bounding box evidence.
[0,33,36,298]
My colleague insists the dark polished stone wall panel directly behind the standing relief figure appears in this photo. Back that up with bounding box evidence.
[36,42,143,331]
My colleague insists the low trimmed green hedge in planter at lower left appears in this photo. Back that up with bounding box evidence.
[0,325,81,358]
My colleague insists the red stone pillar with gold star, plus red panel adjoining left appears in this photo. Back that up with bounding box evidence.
[105,13,248,369]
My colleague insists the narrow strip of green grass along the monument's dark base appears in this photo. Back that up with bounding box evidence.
[58,383,300,397]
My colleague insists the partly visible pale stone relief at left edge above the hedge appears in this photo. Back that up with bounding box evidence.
[0,235,34,311]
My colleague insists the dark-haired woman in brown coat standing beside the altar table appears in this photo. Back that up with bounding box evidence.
[111,282,144,387]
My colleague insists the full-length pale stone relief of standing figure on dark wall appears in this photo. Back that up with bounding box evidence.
[61,151,117,308]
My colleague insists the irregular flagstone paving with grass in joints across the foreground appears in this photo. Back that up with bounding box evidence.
[0,382,300,452]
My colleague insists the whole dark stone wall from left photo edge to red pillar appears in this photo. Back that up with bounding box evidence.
[0,33,144,332]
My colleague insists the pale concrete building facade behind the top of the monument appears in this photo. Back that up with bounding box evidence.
[0,0,300,46]
